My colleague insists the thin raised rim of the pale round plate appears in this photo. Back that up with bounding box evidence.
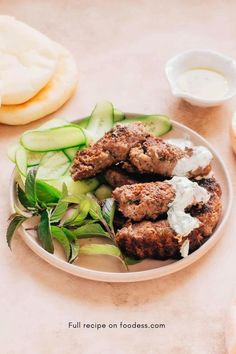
[10,117,233,283]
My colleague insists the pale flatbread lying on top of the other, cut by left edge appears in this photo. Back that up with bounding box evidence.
[0,15,58,105]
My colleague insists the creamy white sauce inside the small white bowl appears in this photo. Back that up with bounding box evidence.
[177,68,229,99]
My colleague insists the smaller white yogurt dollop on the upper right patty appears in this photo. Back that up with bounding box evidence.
[173,146,213,176]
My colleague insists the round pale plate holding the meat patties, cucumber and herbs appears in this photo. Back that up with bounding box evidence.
[11,114,232,282]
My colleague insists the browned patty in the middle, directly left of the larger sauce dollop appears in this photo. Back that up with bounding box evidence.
[112,182,175,221]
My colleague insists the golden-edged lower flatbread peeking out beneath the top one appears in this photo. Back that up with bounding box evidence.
[0,43,78,125]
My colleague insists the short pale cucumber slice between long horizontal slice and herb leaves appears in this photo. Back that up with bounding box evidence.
[37,151,70,180]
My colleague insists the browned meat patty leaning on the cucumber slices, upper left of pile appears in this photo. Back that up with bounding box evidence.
[71,123,149,181]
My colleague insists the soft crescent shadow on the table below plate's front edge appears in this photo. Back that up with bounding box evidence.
[11,235,218,307]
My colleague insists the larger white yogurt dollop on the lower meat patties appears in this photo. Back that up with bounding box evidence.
[167,177,210,237]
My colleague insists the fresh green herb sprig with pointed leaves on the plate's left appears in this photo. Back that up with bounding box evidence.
[7,168,140,270]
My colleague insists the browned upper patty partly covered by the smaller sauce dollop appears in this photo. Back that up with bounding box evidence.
[127,136,211,177]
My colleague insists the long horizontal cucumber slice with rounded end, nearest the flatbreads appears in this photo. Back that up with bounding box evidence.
[20,124,86,152]
